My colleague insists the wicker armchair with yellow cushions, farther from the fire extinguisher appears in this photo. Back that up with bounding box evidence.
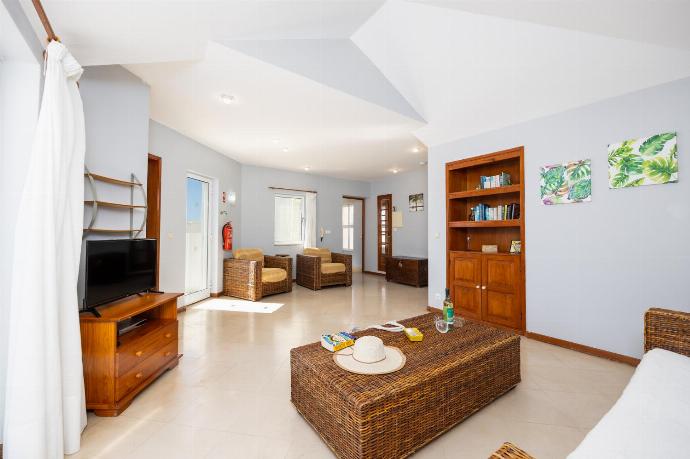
[297,248,352,290]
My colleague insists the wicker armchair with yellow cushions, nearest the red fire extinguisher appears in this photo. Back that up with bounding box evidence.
[223,249,292,301]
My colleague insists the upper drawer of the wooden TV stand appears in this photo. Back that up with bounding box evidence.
[117,320,178,376]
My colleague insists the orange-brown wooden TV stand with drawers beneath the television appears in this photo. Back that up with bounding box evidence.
[79,293,182,416]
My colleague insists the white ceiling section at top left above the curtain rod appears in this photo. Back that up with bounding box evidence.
[21,0,384,65]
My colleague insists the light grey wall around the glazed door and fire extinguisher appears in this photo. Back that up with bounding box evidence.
[149,121,242,292]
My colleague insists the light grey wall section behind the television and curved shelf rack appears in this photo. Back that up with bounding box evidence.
[79,65,149,300]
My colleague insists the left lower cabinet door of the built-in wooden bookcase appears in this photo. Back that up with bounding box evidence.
[449,252,482,319]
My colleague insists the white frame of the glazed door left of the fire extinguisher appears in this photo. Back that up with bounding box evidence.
[181,170,219,306]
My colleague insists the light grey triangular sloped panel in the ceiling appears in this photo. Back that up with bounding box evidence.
[223,39,424,122]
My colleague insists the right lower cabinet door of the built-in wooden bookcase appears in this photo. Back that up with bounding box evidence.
[482,254,522,328]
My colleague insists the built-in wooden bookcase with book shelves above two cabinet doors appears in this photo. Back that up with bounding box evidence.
[446,147,526,330]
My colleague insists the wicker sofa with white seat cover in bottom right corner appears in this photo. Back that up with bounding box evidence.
[491,308,690,459]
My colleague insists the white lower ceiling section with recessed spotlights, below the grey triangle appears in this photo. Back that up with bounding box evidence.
[126,42,426,180]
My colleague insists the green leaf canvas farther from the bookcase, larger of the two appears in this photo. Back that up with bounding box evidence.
[608,132,678,188]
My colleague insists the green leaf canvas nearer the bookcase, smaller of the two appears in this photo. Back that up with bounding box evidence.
[539,159,592,206]
